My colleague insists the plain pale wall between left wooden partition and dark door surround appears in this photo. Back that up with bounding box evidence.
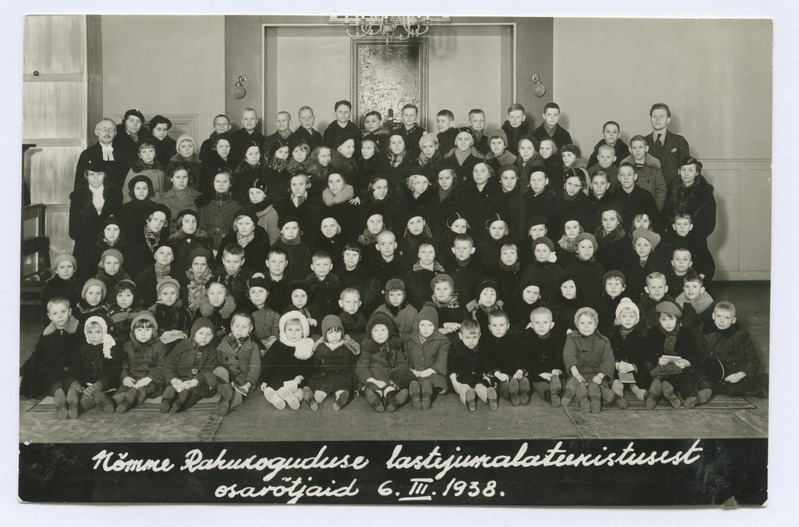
[101,15,225,143]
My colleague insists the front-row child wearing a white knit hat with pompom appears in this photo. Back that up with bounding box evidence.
[608,298,654,408]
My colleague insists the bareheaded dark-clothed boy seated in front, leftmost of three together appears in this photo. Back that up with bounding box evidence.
[447,320,497,412]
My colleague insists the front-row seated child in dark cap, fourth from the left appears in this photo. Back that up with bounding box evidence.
[161,317,217,414]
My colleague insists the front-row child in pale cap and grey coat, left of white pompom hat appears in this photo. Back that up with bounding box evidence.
[561,307,624,413]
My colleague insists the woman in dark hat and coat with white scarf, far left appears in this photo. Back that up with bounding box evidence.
[69,159,122,281]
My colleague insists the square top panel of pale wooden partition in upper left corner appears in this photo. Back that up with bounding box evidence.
[22,15,85,75]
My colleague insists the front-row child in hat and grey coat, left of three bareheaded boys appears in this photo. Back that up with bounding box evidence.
[403,306,450,410]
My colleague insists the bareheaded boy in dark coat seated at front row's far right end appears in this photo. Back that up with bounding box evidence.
[697,301,768,404]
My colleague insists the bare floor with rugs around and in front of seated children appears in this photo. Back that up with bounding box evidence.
[19,282,770,443]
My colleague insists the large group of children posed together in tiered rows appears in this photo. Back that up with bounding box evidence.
[21,101,767,418]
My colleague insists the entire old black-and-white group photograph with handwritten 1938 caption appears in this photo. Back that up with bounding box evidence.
[5,3,795,524]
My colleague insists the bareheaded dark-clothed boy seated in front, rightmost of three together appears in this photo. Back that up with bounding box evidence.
[521,307,566,408]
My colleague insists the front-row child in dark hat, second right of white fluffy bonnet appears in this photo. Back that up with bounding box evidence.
[355,313,413,413]
